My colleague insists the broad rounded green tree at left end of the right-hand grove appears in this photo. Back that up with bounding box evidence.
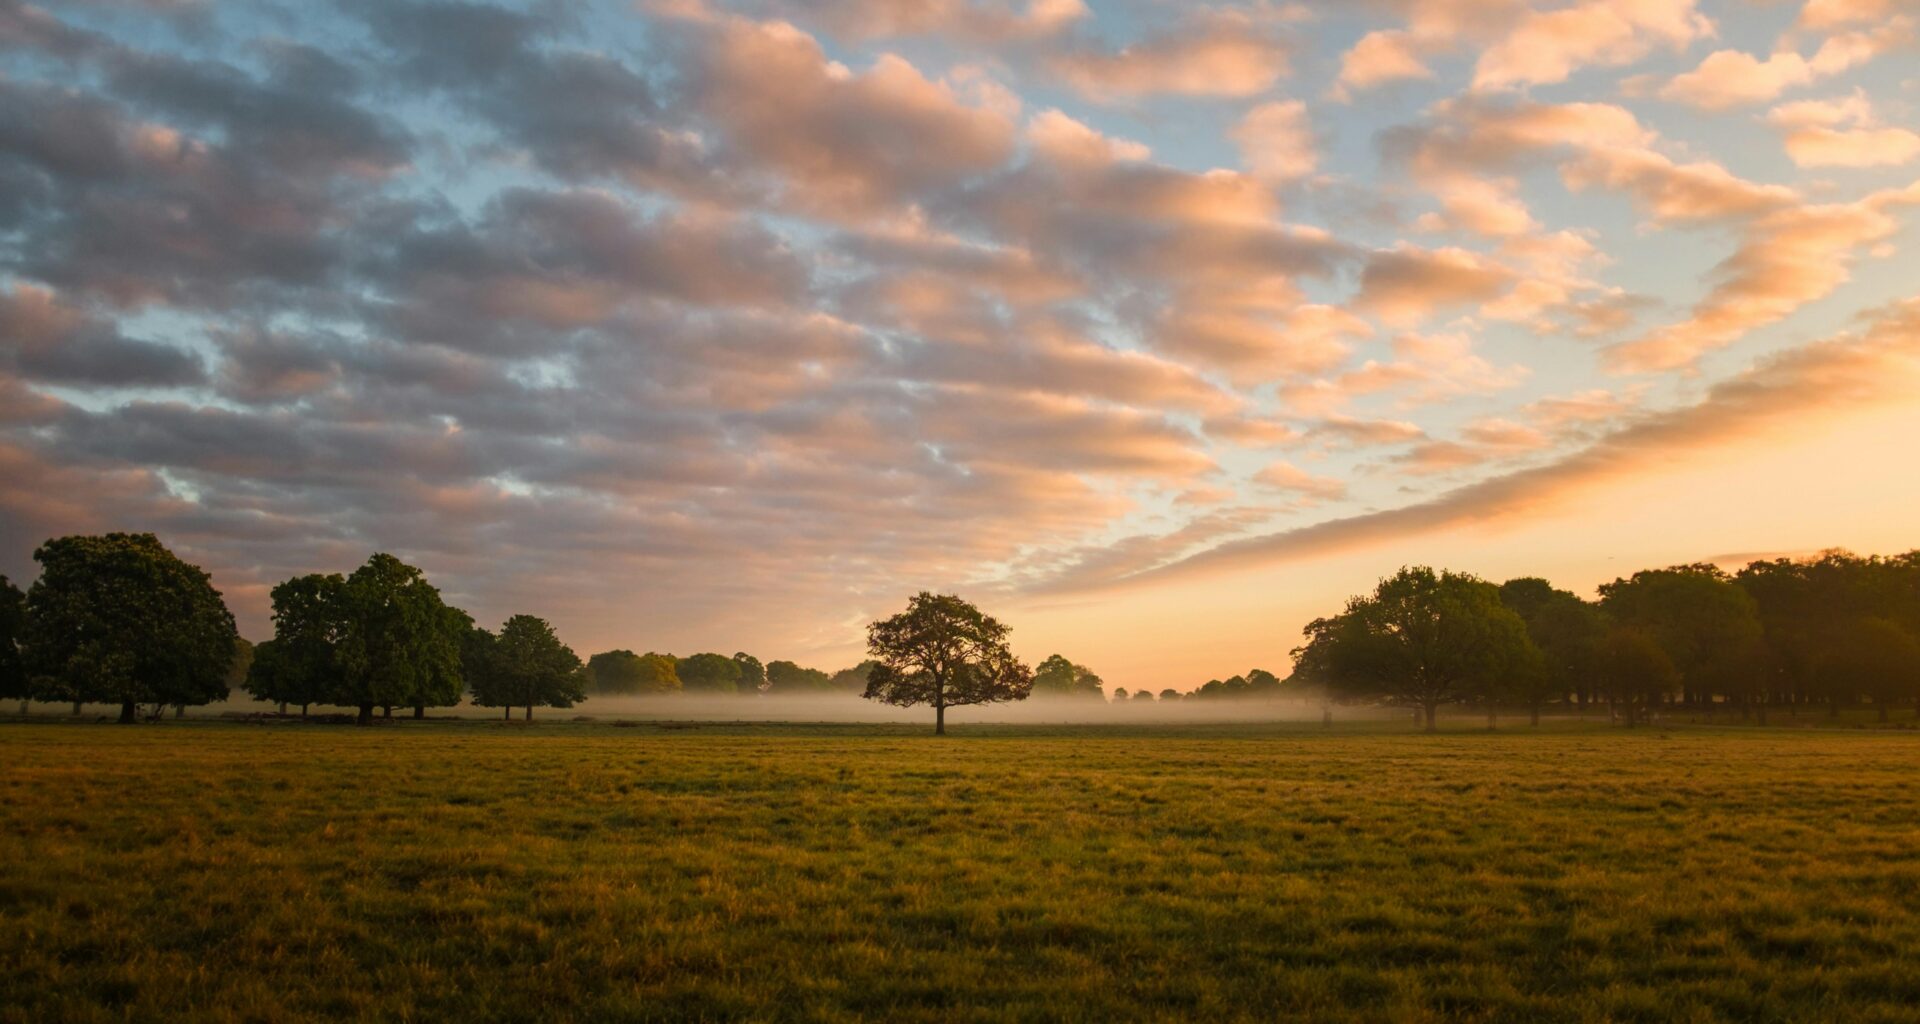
[1294,567,1538,732]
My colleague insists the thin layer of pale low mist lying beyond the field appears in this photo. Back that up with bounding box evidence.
[74,694,1402,726]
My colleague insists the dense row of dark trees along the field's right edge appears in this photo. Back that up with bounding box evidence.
[1286,551,1920,730]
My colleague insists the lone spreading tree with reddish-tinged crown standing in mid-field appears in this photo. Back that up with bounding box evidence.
[864,592,1033,736]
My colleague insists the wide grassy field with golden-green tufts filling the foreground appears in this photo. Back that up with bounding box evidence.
[0,722,1920,1022]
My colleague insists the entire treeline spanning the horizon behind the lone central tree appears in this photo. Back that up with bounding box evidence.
[0,534,1920,728]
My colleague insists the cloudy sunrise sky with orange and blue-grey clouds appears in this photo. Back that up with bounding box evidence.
[0,0,1920,690]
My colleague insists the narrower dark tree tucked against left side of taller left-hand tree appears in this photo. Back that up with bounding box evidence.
[244,573,351,715]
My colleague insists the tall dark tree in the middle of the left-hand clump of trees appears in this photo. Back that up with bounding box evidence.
[323,553,465,724]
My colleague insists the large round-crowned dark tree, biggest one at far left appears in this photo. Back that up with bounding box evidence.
[25,534,240,722]
